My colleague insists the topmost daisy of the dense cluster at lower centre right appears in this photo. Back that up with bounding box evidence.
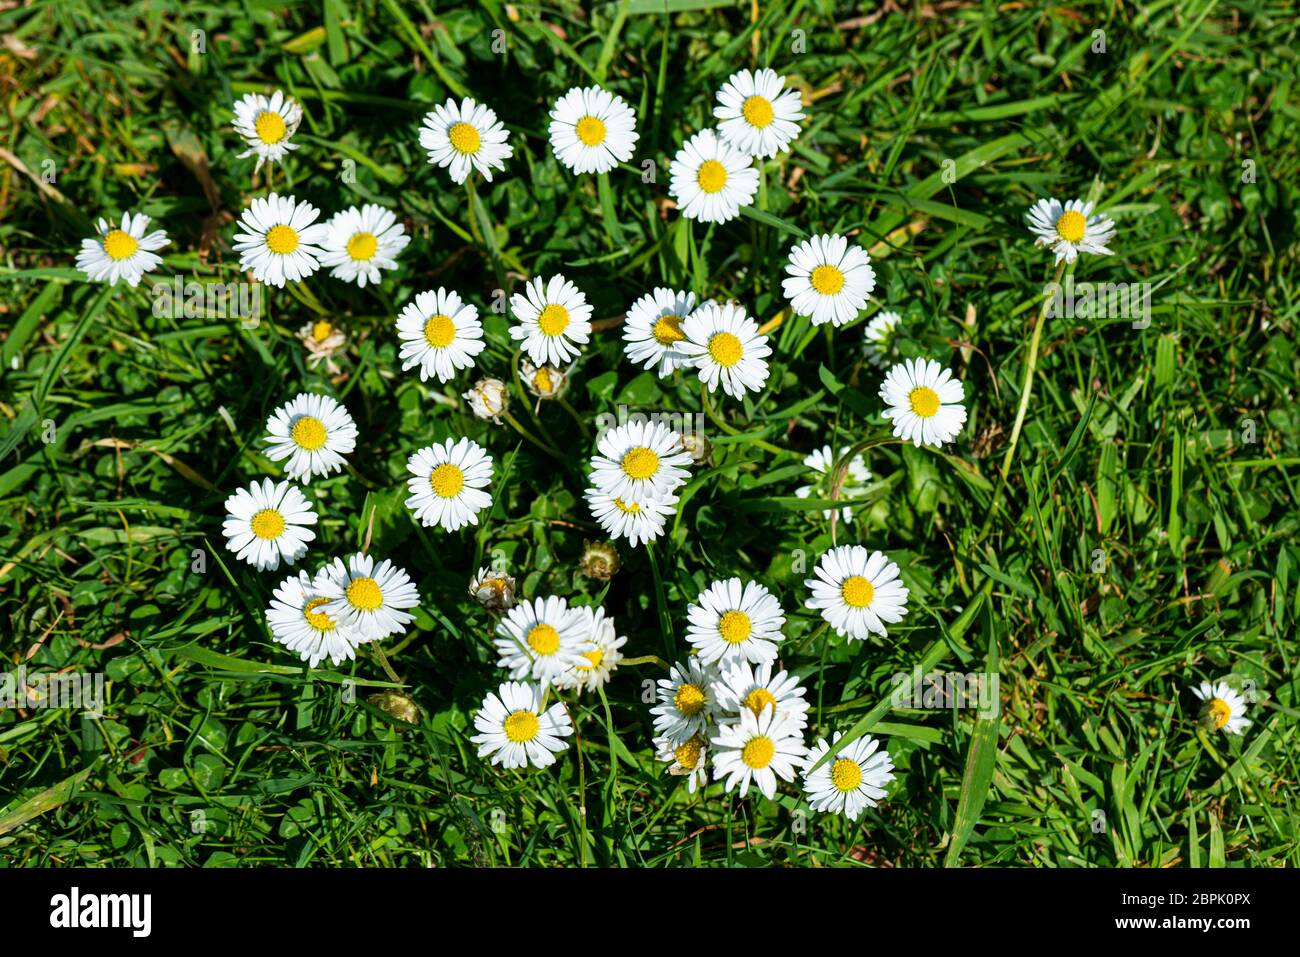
[686,579,785,664]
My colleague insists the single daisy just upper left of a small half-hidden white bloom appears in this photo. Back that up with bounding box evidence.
[781,233,876,326]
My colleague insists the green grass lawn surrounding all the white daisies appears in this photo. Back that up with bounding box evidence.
[0,0,1300,867]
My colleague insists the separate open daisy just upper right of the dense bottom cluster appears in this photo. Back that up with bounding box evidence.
[803,545,907,641]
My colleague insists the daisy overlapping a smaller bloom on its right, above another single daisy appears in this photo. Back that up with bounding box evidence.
[495,596,595,685]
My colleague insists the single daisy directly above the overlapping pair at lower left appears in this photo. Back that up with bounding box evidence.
[221,479,316,571]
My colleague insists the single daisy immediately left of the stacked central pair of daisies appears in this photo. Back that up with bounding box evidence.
[406,438,491,532]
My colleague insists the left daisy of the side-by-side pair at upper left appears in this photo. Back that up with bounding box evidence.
[234,192,328,289]
